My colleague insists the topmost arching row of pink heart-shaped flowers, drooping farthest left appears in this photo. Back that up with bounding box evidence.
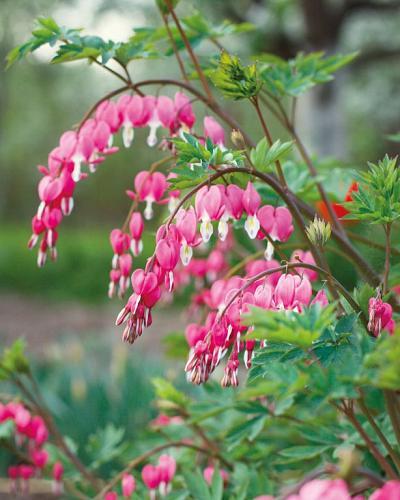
[28,92,227,267]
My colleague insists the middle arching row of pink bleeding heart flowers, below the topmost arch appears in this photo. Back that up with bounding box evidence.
[114,178,293,343]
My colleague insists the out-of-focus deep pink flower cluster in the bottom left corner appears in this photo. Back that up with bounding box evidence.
[0,401,64,495]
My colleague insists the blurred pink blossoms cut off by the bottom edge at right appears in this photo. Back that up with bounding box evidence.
[254,479,400,500]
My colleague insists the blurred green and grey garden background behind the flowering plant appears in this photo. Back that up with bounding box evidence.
[0,0,400,462]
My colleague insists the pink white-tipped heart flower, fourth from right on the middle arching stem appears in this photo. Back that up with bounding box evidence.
[195,186,225,243]
